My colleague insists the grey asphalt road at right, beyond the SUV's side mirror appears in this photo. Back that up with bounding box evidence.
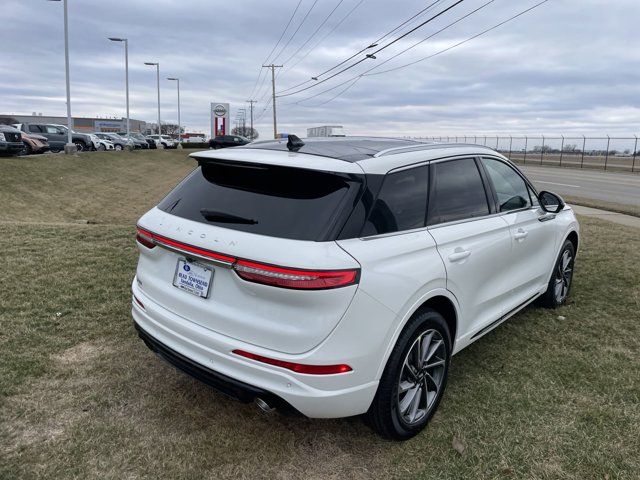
[518,165,640,206]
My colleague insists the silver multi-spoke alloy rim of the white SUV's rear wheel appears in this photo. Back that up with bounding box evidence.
[397,330,447,425]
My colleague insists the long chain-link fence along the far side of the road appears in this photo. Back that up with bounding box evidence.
[414,135,640,172]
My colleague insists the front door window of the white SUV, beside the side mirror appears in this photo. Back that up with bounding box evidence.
[482,158,531,212]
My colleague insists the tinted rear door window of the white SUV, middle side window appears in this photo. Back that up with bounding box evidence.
[429,158,489,225]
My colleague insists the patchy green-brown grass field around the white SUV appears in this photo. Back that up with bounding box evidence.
[0,151,640,480]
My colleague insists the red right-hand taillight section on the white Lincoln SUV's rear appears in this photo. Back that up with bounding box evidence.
[233,260,359,290]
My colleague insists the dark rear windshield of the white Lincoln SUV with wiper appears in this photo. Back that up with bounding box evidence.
[158,162,363,241]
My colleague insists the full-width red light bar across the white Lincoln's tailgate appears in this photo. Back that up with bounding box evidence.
[136,227,360,290]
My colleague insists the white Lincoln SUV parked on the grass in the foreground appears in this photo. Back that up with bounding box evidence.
[132,136,579,439]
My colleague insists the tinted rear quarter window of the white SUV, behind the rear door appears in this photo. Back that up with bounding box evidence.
[362,165,429,237]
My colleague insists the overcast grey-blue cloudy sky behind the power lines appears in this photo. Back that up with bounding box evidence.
[0,0,640,138]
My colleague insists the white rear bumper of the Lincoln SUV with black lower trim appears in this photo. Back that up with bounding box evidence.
[131,280,378,418]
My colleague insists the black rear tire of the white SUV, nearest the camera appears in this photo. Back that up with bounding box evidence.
[366,308,451,440]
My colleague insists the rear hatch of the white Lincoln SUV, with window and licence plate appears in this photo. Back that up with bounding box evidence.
[137,156,364,354]
